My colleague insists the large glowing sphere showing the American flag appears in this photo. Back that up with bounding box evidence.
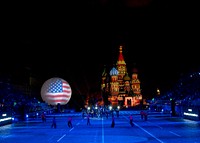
[41,77,72,105]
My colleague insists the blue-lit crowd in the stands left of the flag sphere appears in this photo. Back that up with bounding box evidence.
[0,82,52,120]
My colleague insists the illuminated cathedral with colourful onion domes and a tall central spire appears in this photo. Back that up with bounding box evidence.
[101,46,142,108]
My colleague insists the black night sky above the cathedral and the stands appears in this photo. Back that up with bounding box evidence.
[1,0,200,99]
